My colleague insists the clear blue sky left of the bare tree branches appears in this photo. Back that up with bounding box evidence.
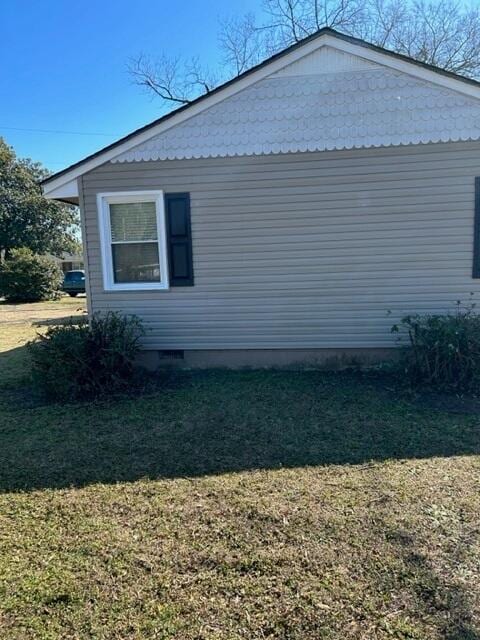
[0,0,260,171]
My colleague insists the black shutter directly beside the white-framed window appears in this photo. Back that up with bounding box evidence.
[165,193,193,287]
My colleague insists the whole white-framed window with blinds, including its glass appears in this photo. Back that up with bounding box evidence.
[97,191,168,291]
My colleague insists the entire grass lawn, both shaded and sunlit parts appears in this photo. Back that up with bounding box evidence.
[0,299,480,640]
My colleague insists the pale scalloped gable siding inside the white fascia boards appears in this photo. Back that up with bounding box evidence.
[112,45,480,162]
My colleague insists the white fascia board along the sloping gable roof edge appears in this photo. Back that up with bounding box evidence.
[43,34,480,197]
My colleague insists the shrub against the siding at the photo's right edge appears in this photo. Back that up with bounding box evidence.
[392,301,480,392]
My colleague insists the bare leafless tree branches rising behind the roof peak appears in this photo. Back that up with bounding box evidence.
[128,0,480,106]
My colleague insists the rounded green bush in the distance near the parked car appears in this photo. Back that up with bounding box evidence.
[0,249,63,302]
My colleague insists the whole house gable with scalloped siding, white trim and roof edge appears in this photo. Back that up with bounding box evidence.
[43,28,480,198]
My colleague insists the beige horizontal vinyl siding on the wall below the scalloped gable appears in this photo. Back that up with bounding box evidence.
[82,142,480,349]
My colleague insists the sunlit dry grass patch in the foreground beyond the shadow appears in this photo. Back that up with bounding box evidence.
[0,458,480,640]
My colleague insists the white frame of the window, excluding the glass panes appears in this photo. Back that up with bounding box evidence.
[97,190,170,291]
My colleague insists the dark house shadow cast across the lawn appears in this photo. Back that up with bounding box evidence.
[0,349,480,491]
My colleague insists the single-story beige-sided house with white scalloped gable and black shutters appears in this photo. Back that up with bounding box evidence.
[43,29,480,366]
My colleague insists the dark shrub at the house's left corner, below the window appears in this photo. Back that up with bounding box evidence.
[28,312,144,400]
